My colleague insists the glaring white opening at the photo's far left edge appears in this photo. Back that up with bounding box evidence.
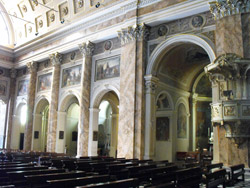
[0,99,7,149]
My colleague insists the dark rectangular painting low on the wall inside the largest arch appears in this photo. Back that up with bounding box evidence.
[156,117,169,141]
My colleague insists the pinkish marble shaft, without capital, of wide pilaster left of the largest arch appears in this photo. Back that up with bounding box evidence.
[117,41,136,158]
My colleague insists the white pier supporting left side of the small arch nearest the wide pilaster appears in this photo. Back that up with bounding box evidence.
[88,108,100,156]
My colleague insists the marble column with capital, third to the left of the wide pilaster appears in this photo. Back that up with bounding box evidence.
[24,61,37,151]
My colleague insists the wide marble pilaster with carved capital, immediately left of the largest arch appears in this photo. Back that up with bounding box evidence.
[117,25,144,158]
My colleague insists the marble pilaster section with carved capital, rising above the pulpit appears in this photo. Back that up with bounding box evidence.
[210,0,250,58]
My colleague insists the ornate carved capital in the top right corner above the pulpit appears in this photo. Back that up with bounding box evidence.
[209,0,250,20]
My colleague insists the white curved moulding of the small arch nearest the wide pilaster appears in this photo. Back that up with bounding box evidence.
[90,84,120,108]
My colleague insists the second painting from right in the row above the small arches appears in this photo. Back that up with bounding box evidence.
[61,65,82,88]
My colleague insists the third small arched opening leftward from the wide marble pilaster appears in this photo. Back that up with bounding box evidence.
[32,98,49,152]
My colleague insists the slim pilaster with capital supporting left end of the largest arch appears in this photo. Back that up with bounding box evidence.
[144,75,159,159]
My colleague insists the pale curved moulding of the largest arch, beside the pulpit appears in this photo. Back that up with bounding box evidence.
[146,34,216,75]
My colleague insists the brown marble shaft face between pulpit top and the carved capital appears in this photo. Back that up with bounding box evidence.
[215,14,243,57]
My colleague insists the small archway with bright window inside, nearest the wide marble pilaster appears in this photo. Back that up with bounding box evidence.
[89,88,119,157]
